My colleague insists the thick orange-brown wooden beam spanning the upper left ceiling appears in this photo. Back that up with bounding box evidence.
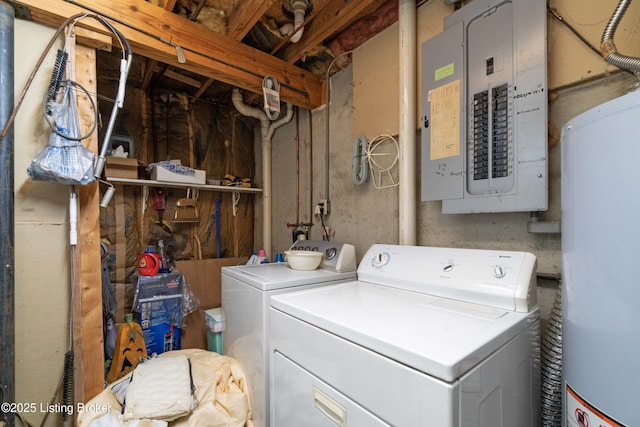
[16,0,323,109]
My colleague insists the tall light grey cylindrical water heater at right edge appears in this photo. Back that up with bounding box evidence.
[561,88,640,427]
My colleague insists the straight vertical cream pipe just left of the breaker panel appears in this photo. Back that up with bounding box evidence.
[398,0,417,245]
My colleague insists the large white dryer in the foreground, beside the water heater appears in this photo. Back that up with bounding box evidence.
[269,245,540,427]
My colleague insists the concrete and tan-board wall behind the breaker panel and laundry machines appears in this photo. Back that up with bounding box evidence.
[268,0,640,324]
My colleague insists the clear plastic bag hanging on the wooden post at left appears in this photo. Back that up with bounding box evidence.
[27,84,95,185]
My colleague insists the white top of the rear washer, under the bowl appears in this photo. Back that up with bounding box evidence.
[222,263,356,291]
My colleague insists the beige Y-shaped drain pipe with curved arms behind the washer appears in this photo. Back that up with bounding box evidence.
[231,88,293,255]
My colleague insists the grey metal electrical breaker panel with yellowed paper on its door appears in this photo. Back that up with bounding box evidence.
[421,0,548,213]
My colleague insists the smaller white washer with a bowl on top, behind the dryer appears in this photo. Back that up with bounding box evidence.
[222,240,356,427]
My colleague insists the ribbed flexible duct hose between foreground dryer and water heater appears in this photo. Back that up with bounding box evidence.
[540,288,562,427]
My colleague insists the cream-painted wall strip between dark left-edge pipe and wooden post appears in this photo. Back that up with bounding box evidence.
[14,20,70,426]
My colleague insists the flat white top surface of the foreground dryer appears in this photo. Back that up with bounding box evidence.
[271,281,538,382]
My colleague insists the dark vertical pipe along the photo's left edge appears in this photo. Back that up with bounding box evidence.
[0,1,15,427]
